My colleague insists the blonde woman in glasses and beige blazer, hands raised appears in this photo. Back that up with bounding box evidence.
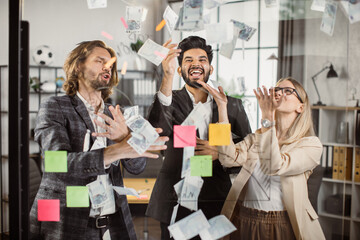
[200,77,325,240]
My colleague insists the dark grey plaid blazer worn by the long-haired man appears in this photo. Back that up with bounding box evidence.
[30,95,146,240]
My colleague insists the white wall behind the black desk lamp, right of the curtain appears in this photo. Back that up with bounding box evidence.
[304,2,360,106]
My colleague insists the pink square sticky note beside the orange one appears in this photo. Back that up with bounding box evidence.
[174,125,196,148]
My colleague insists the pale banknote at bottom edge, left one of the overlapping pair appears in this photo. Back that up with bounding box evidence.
[168,210,210,240]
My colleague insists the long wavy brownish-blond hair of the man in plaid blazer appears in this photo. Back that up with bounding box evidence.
[63,40,119,100]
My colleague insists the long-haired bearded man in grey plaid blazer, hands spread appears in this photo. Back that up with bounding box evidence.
[30,41,167,240]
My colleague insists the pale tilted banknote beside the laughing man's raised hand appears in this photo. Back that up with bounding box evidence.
[138,39,169,66]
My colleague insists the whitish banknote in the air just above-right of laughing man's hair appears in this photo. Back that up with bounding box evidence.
[205,22,234,44]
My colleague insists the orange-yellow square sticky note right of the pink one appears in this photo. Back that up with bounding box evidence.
[209,123,231,146]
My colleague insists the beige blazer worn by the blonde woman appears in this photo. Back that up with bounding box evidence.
[218,127,325,240]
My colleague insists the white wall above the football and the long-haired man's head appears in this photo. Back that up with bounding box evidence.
[24,0,159,69]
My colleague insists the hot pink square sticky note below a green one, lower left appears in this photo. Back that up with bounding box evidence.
[38,199,60,222]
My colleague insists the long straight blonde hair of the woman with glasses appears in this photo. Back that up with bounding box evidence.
[275,77,315,145]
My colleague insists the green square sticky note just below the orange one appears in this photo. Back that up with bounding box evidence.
[190,155,212,177]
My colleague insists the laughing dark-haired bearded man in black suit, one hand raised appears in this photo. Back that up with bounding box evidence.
[146,36,251,239]
